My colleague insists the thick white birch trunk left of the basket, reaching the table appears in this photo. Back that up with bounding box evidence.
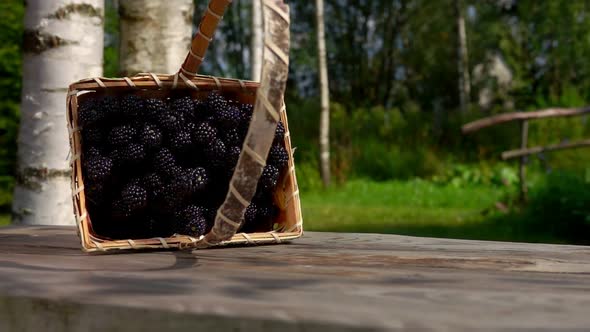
[12,0,104,225]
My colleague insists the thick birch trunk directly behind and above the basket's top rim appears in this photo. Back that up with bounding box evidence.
[119,0,193,76]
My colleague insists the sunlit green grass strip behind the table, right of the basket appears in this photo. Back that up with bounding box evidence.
[301,180,561,242]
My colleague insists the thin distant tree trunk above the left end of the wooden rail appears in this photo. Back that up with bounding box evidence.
[455,0,471,114]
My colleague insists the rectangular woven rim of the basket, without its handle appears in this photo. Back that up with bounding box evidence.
[67,74,303,252]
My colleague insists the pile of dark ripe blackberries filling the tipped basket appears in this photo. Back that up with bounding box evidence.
[78,91,289,239]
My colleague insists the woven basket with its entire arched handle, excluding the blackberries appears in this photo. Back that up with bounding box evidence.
[67,0,303,252]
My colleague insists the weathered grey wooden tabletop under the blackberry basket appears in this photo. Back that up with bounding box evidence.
[0,227,590,332]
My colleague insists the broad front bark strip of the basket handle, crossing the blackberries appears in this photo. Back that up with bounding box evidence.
[181,0,290,248]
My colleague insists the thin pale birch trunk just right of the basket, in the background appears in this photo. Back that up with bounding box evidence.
[316,0,330,187]
